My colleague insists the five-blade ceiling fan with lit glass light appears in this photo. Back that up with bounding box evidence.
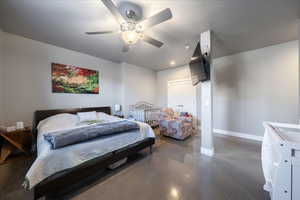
[86,0,172,52]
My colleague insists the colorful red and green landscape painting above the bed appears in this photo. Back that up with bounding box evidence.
[52,63,99,94]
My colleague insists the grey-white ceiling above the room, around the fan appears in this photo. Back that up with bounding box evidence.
[0,0,300,70]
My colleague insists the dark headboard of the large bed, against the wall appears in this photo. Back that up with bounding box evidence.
[32,106,111,152]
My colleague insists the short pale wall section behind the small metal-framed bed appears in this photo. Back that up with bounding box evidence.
[122,63,156,116]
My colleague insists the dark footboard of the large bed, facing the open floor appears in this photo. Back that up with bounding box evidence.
[34,138,155,200]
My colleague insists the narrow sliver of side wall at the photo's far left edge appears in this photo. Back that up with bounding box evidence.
[0,29,4,125]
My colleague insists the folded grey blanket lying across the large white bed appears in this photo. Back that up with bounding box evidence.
[44,120,139,149]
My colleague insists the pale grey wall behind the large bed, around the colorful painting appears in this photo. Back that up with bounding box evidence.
[4,33,122,125]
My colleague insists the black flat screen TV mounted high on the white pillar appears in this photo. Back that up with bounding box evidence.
[189,42,210,85]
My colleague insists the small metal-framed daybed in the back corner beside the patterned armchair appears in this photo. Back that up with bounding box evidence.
[129,101,161,127]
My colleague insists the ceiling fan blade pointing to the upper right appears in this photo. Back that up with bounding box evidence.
[140,8,172,28]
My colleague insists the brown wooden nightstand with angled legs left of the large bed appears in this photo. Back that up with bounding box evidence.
[0,128,32,164]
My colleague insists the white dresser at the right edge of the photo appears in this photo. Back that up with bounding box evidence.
[262,122,300,200]
